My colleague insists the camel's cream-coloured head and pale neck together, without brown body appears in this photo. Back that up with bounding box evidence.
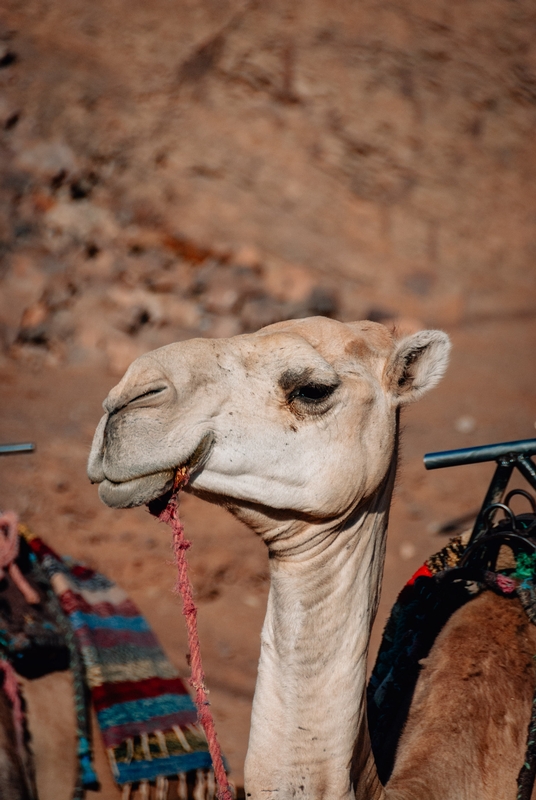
[88,318,448,800]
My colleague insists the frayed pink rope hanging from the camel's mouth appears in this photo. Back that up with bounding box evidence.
[158,470,232,800]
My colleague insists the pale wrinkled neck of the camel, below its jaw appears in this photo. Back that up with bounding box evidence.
[245,480,392,800]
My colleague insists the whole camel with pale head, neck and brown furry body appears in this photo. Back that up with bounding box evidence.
[88,317,536,800]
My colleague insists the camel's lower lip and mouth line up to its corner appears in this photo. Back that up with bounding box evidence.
[99,431,214,508]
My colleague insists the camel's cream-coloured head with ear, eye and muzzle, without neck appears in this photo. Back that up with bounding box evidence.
[88,317,450,528]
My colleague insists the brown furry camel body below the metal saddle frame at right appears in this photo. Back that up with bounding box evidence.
[387,591,536,800]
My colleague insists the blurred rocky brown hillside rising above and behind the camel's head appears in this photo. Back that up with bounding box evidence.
[0,0,536,372]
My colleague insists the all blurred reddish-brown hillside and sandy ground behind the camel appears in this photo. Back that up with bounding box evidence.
[0,0,536,798]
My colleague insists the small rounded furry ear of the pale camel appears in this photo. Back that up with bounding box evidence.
[385,331,450,405]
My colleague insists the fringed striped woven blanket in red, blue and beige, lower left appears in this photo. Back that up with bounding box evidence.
[21,526,214,798]
